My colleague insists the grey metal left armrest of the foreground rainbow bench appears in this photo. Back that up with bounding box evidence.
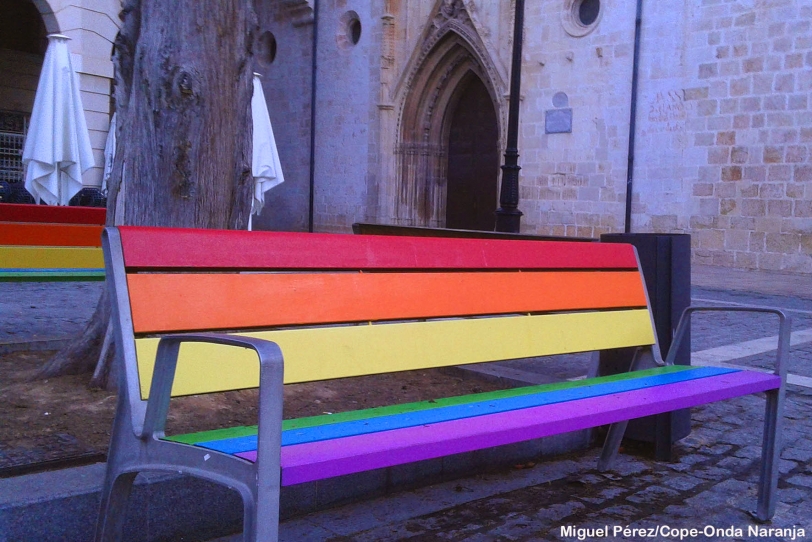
[139,333,284,444]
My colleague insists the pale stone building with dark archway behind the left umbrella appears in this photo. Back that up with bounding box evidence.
[0,0,121,191]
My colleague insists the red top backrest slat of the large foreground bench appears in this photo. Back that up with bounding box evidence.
[119,227,637,270]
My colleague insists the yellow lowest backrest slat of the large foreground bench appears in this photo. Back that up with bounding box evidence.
[136,309,654,396]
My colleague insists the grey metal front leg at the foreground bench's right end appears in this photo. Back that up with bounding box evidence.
[754,388,784,521]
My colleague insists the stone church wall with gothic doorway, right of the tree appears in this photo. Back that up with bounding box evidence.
[260,0,812,273]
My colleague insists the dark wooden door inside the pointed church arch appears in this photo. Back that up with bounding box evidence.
[446,77,499,231]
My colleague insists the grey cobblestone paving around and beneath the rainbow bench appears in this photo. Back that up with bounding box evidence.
[0,266,812,541]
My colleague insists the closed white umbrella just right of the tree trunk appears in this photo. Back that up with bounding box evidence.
[248,73,285,230]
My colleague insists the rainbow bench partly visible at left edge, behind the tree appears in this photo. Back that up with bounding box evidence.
[0,203,106,282]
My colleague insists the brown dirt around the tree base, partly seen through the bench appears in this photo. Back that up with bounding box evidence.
[0,351,505,476]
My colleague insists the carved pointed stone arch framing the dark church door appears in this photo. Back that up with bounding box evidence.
[394,11,504,227]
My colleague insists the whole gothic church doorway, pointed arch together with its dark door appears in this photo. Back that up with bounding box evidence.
[394,27,501,230]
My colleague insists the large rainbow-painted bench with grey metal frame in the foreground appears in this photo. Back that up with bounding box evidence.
[97,227,789,541]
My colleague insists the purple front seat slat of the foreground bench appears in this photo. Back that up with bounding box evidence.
[236,371,781,486]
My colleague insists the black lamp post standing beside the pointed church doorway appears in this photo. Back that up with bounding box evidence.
[495,0,524,233]
